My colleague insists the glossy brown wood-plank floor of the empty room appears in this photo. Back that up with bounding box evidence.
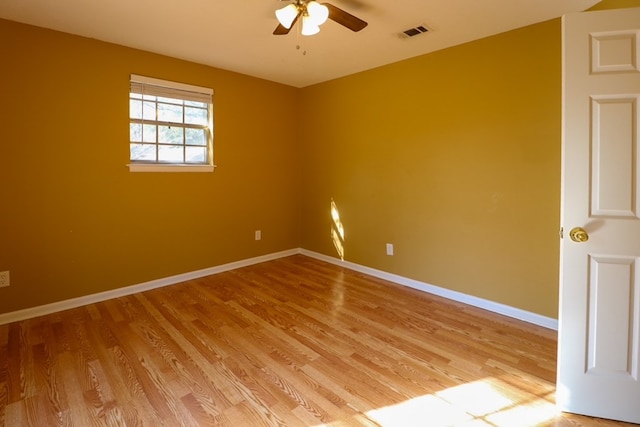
[0,256,629,427]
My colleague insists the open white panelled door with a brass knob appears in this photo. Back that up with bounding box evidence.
[557,8,640,423]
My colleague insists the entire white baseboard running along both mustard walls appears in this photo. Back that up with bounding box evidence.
[0,248,558,330]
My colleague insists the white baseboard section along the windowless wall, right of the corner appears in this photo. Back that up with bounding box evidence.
[300,249,558,331]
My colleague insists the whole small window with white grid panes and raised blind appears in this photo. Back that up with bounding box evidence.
[129,75,213,172]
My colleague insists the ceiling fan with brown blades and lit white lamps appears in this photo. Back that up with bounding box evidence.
[273,0,368,36]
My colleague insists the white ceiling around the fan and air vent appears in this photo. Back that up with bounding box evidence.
[0,0,600,87]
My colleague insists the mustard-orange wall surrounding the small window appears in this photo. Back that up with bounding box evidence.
[0,20,299,313]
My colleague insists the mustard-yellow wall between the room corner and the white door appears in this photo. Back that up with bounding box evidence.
[301,20,561,317]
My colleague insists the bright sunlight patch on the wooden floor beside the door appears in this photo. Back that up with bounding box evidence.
[318,378,560,427]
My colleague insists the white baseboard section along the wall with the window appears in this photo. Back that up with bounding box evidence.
[0,249,300,325]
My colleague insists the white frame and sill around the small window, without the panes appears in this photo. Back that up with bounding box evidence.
[127,74,215,172]
